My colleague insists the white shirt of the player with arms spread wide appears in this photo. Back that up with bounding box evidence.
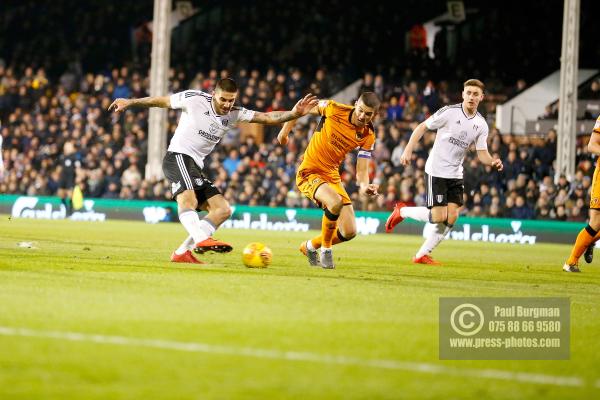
[167,90,254,168]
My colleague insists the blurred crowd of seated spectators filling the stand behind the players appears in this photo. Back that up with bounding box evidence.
[0,65,594,221]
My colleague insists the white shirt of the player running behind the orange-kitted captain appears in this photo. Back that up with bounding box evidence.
[425,104,489,179]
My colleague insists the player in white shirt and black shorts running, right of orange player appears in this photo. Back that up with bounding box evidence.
[385,79,503,265]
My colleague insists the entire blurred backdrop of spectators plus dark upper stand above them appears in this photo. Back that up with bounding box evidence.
[0,0,600,221]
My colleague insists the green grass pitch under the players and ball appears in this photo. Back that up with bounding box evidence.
[0,216,600,400]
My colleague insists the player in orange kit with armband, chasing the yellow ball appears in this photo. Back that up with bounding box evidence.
[277,92,381,269]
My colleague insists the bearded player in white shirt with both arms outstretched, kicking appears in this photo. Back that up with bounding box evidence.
[108,78,317,264]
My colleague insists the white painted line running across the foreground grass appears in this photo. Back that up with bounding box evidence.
[0,326,600,388]
